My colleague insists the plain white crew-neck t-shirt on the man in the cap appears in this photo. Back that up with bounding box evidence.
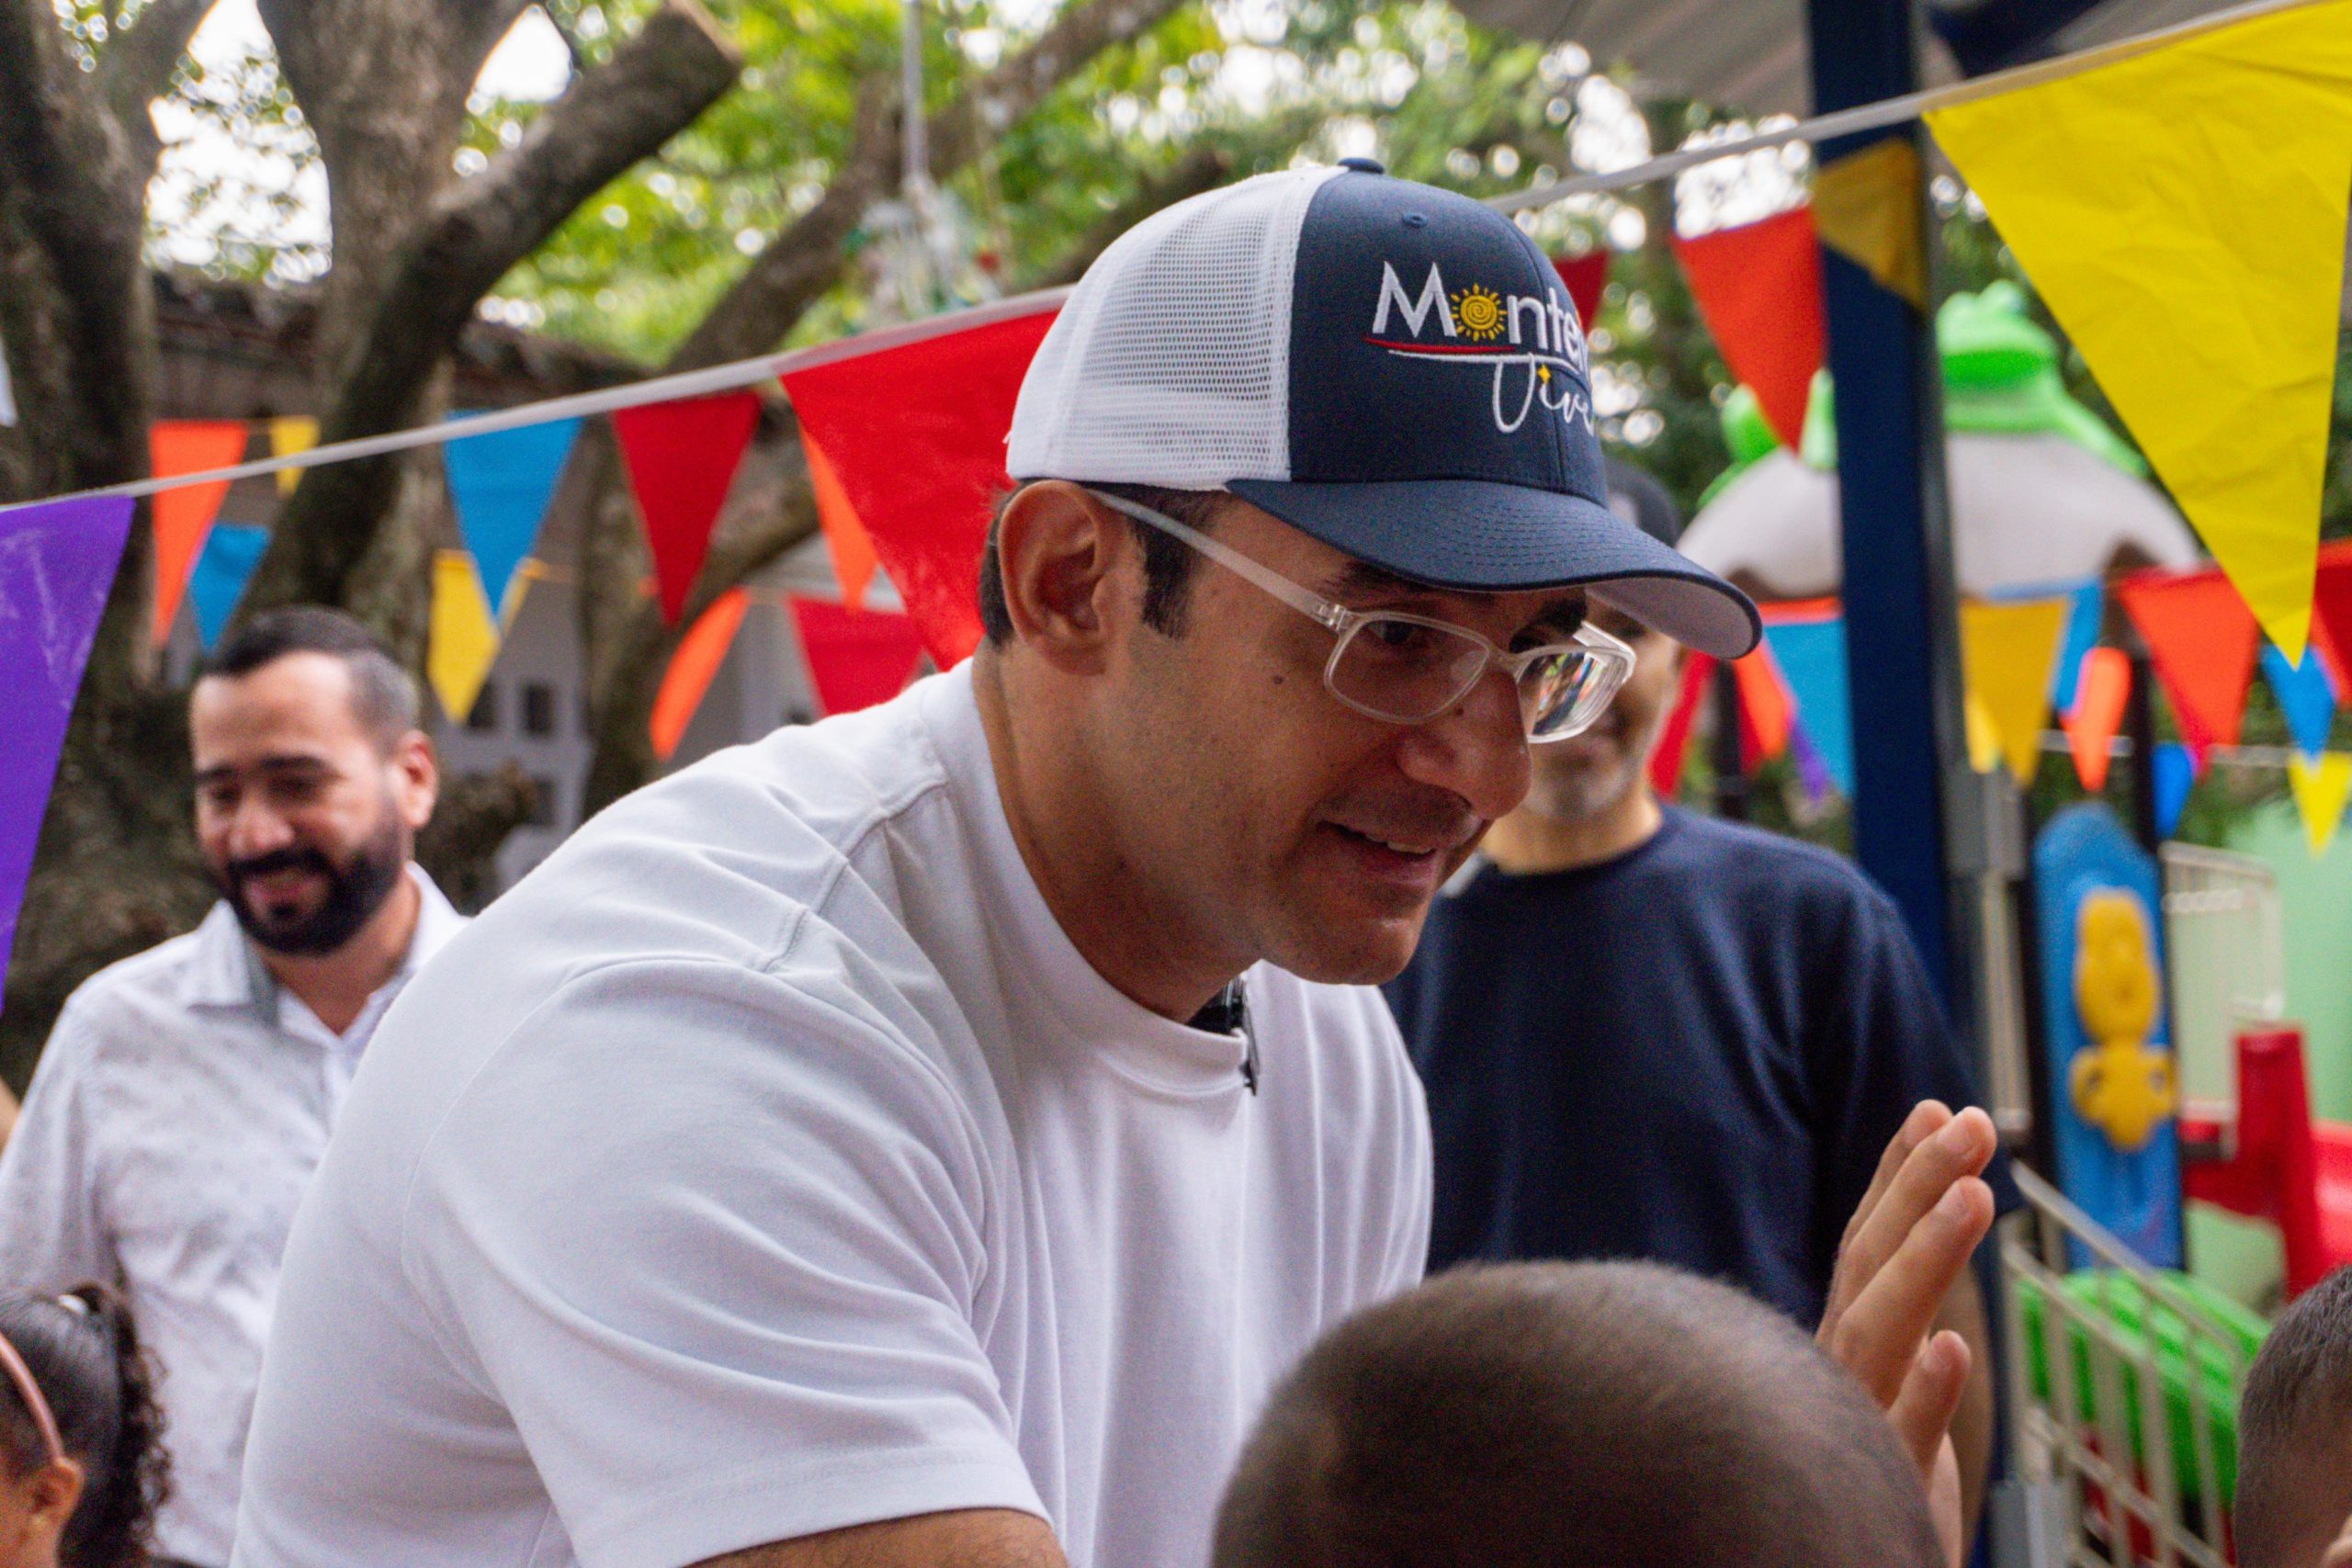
[232,668,1430,1568]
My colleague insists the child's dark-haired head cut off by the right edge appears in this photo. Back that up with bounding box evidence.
[2237,1269,2352,1568]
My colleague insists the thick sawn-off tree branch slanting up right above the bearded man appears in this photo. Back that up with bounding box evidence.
[240,0,743,616]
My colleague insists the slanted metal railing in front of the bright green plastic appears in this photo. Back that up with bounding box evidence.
[1999,1166,2251,1568]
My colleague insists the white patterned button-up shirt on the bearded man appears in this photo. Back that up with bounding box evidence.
[0,865,466,1563]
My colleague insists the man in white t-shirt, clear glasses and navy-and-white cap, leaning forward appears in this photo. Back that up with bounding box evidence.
[235,167,1992,1568]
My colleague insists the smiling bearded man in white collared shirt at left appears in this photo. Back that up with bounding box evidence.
[0,609,463,1563]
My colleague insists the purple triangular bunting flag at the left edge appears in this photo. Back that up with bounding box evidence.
[0,496,131,1001]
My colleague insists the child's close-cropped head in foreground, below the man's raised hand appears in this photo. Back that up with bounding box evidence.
[1216,1262,1943,1568]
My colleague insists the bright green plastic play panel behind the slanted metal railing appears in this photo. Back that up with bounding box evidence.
[2016,1269,2269,1506]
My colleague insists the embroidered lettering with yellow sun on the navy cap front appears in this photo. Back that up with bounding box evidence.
[1364,261,1592,434]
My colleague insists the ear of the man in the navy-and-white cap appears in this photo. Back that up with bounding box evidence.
[997,479,1138,674]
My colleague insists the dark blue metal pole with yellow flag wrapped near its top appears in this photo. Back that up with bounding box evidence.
[1809,0,1973,1027]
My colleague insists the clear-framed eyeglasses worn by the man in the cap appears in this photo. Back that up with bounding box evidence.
[1087,489,1633,745]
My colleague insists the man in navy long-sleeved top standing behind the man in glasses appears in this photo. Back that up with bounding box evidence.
[1387,458,2020,1514]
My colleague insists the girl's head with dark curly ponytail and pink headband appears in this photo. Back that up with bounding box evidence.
[0,1286,164,1568]
